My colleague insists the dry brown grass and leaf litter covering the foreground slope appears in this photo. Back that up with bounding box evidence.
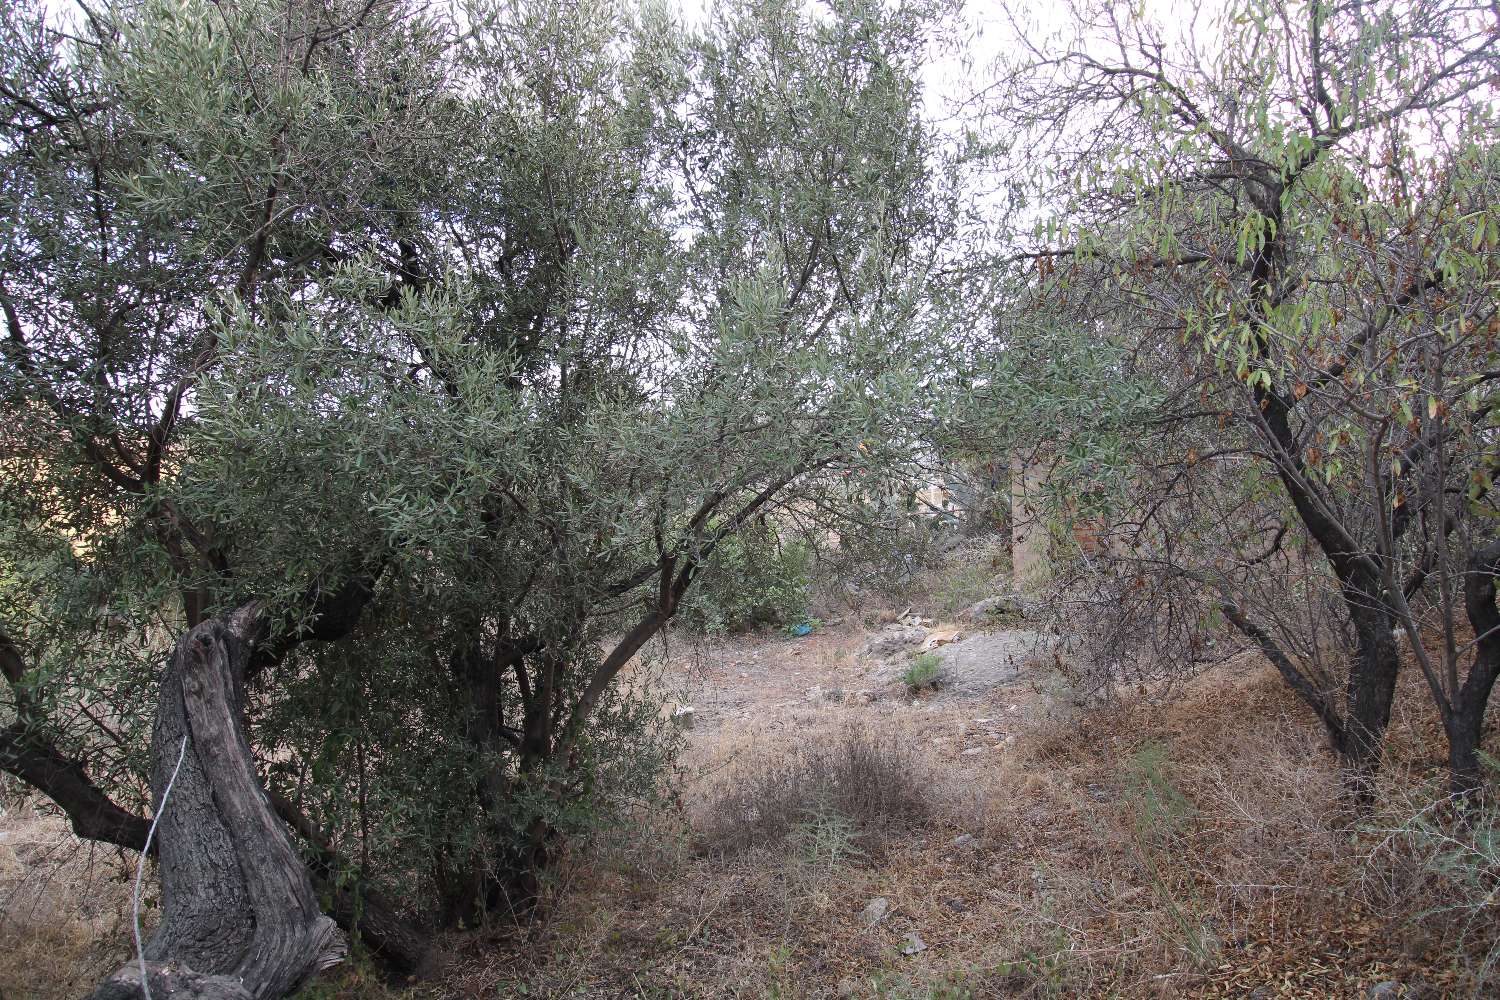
[423,660,1493,1000]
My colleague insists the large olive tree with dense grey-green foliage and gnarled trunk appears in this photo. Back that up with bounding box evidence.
[0,0,953,997]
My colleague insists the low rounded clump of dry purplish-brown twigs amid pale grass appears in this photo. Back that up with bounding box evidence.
[701,726,932,858]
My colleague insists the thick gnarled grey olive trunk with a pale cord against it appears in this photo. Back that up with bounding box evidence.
[92,604,344,1000]
